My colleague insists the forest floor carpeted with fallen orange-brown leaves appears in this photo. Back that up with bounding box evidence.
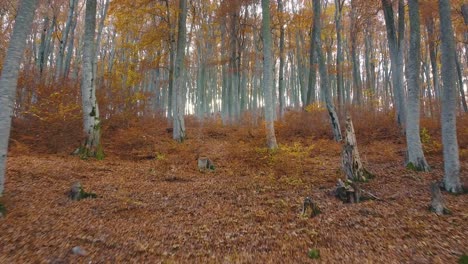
[0,110,468,263]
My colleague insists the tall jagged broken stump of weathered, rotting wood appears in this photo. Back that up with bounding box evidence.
[341,115,369,182]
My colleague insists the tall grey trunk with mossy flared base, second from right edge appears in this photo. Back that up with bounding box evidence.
[406,0,430,171]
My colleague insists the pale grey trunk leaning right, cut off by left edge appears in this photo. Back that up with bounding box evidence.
[0,0,37,196]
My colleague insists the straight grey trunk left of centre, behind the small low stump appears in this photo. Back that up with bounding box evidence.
[172,0,187,142]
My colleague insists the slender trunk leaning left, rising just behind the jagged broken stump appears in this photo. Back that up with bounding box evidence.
[312,0,342,141]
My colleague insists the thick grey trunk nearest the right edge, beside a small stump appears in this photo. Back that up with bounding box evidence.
[439,0,462,193]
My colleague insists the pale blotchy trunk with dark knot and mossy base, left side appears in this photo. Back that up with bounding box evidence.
[80,0,103,159]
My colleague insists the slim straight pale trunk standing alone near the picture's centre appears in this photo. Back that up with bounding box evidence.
[262,0,278,149]
